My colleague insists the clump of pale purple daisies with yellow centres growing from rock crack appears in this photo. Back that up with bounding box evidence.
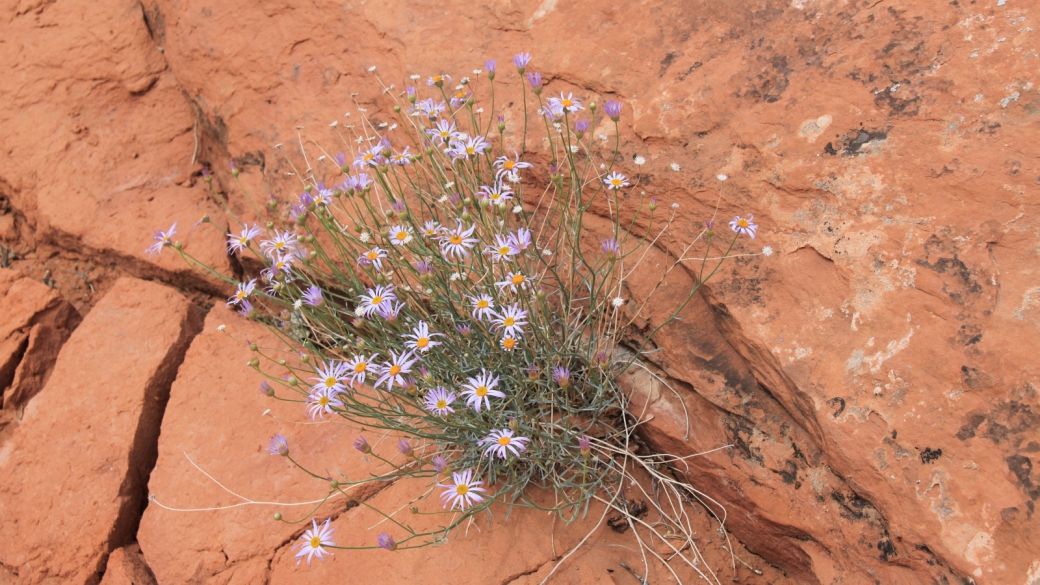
[162,52,772,563]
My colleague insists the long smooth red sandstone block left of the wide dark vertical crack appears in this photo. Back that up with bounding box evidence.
[0,279,201,584]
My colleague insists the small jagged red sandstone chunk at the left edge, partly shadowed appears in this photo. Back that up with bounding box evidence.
[0,271,80,410]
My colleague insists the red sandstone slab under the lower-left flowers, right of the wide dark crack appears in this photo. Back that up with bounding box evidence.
[137,306,391,583]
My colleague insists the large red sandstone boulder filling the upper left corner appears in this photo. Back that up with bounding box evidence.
[0,0,232,289]
